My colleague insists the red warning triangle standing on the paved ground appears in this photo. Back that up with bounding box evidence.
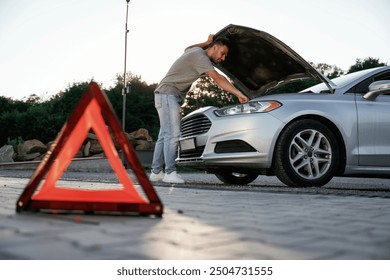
[16,83,163,216]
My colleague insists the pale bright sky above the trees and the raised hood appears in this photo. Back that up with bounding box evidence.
[0,0,390,100]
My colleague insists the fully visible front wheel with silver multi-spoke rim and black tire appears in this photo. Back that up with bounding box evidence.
[274,120,340,187]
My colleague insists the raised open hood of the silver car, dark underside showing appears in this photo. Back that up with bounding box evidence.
[214,24,332,98]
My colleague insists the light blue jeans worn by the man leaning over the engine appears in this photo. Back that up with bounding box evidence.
[152,93,181,174]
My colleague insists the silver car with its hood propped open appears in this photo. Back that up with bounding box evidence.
[177,25,390,187]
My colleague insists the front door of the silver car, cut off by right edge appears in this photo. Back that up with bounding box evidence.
[354,72,390,166]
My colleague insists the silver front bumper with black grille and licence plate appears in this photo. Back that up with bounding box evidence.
[176,108,283,171]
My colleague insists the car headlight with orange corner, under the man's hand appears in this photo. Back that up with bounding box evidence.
[214,101,282,117]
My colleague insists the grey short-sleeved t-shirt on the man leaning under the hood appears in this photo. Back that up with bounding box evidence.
[155,47,215,99]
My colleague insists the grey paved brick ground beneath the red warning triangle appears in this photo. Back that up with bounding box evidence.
[0,172,390,260]
